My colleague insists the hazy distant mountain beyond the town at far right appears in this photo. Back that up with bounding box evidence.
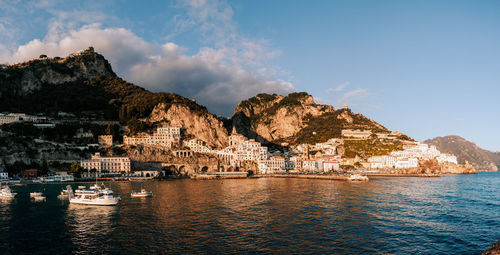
[424,135,500,171]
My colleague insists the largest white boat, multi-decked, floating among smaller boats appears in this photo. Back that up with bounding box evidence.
[67,184,120,205]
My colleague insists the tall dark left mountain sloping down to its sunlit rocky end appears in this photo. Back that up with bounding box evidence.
[0,48,227,147]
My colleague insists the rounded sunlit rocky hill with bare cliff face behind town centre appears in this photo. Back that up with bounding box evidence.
[232,92,387,144]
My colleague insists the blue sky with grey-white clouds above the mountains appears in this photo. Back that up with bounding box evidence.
[0,0,500,151]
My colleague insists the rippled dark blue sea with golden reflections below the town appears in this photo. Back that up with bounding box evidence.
[0,172,500,254]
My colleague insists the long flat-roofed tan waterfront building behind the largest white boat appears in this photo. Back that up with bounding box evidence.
[80,152,130,173]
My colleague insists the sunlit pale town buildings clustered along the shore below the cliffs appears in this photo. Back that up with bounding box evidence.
[81,127,457,174]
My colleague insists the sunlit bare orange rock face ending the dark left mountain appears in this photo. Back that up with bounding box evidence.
[148,103,229,148]
